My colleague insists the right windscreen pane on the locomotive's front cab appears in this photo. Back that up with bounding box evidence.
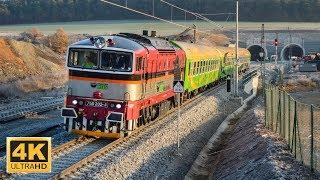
[101,51,132,72]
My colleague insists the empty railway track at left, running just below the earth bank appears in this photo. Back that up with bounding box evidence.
[0,96,64,124]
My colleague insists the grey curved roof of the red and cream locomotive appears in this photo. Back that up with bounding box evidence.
[70,33,176,51]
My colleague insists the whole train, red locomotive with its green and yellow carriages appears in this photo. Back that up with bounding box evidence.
[61,33,251,138]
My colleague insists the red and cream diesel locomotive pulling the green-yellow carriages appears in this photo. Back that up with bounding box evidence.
[61,33,186,138]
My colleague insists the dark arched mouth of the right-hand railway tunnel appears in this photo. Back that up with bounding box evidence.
[280,43,305,61]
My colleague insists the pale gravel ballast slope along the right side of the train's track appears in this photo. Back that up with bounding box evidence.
[73,86,240,179]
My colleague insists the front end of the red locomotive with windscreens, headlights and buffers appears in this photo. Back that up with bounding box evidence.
[61,36,142,138]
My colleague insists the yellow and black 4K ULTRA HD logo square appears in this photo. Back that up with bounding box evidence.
[7,137,51,173]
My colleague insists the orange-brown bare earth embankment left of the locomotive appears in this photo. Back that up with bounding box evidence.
[0,39,67,97]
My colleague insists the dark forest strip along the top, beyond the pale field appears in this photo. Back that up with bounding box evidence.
[0,0,320,24]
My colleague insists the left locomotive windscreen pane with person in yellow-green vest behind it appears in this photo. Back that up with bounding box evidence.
[68,49,98,69]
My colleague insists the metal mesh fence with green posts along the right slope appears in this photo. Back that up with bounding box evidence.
[265,85,320,172]
